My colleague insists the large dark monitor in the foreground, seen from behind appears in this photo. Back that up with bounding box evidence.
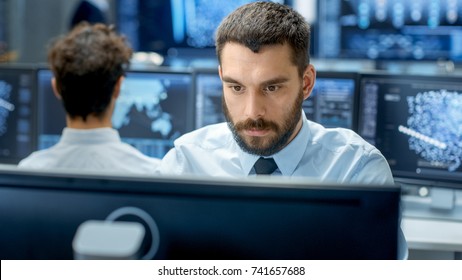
[0,165,400,260]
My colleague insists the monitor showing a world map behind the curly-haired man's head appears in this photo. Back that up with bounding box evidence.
[38,68,194,158]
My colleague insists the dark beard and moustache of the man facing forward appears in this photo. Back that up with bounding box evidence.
[222,89,303,156]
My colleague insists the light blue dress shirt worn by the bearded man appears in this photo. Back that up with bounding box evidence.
[159,114,394,184]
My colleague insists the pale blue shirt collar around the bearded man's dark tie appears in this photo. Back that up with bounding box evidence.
[236,112,311,176]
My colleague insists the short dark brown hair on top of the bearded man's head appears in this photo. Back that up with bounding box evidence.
[215,2,310,75]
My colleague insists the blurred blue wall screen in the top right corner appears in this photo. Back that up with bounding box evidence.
[317,0,462,61]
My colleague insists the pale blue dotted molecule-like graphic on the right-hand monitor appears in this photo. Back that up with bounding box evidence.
[398,90,462,171]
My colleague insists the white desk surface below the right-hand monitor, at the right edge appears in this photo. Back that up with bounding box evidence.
[401,217,462,252]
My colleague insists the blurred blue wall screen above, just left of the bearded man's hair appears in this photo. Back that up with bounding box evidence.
[116,0,284,57]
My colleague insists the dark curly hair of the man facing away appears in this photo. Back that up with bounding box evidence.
[48,22,132,121]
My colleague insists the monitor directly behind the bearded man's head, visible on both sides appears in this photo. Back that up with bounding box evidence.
[194,68,358,129]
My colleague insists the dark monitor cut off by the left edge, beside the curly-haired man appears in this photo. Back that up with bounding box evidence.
[0,65,36,164]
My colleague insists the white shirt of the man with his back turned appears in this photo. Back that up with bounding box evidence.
[18,128,160,174]
